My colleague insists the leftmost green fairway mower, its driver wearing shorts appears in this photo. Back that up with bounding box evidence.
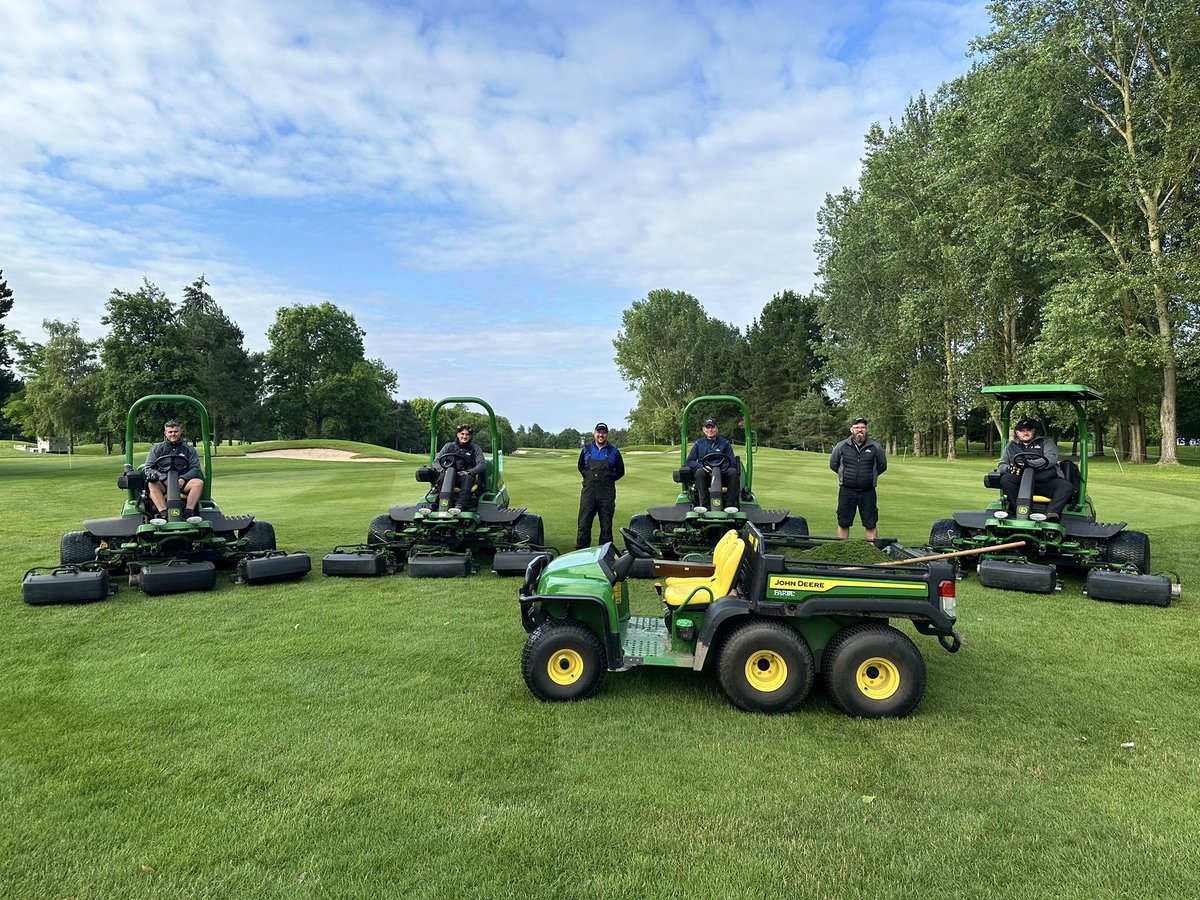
[24,394,312,605]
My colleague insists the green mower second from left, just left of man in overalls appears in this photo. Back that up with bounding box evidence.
[322,397,556,578]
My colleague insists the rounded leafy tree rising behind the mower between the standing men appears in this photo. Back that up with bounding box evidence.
[612,290,746,443]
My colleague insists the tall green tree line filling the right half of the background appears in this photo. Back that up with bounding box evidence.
[614,0,1200,463]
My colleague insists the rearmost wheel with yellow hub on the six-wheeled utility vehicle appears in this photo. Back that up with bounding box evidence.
[821,623,925,719]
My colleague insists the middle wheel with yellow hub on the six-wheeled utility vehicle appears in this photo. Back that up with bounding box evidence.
[718,619,816,714]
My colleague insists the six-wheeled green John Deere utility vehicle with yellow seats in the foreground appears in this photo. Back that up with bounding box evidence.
[521,522,961,719]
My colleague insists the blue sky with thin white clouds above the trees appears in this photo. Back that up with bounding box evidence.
[0,0,988,431]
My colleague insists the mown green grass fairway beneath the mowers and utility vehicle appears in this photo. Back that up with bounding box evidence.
[0,451,1200,900]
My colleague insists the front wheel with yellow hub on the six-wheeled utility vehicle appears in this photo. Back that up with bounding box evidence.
[521,619,607,702]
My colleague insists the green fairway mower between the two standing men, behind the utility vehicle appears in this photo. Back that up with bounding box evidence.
[629,395,812,559]
